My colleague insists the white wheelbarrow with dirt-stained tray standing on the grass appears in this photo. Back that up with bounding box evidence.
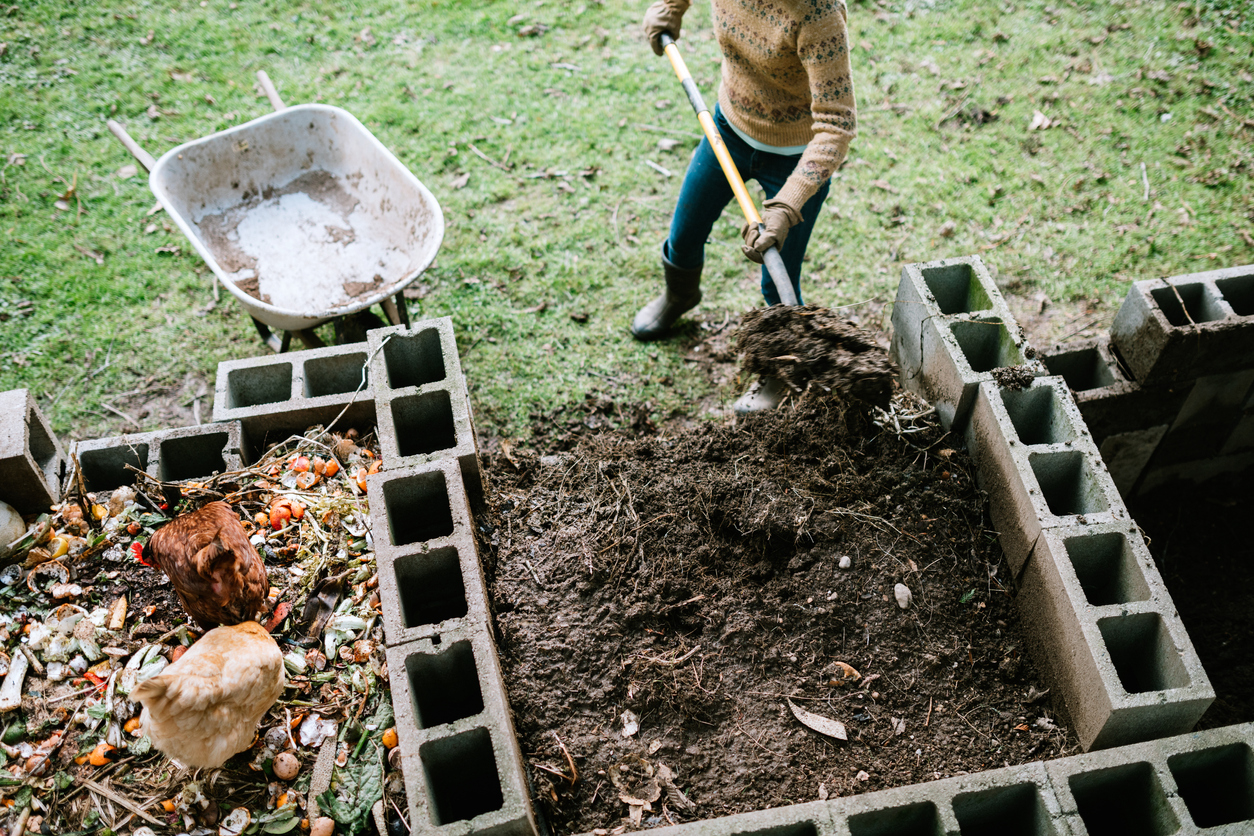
[108,71,444,352]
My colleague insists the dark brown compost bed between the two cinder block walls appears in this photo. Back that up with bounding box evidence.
[479,389,1075,833]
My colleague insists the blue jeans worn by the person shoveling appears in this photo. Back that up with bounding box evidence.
[662,105,831,305]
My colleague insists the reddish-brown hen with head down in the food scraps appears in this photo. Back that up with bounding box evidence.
[143,503,270,629]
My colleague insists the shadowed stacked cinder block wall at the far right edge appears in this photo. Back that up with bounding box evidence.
[1043,266,1254,496]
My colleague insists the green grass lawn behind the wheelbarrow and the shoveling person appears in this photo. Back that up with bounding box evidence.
[0,0,1254,439]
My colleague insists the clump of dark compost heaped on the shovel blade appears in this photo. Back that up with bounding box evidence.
[735,305,895,407]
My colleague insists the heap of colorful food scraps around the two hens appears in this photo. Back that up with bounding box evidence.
[0,430,405,836]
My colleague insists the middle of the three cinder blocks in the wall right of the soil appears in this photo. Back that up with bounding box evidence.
[967,377,1130,577]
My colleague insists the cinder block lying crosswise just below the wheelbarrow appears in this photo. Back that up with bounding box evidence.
[213,343,375,462]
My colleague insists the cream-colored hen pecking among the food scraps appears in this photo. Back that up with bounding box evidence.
[130,622,287,767]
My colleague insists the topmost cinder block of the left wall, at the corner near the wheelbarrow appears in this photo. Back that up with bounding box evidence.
[366,317,484,508]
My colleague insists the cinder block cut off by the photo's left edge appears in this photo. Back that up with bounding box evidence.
[0,389,68,513]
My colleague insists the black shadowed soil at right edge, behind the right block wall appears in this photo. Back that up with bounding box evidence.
[1130,476,1254,728]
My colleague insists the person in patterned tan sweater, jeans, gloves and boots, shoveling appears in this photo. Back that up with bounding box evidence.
[631,0,856,414]
